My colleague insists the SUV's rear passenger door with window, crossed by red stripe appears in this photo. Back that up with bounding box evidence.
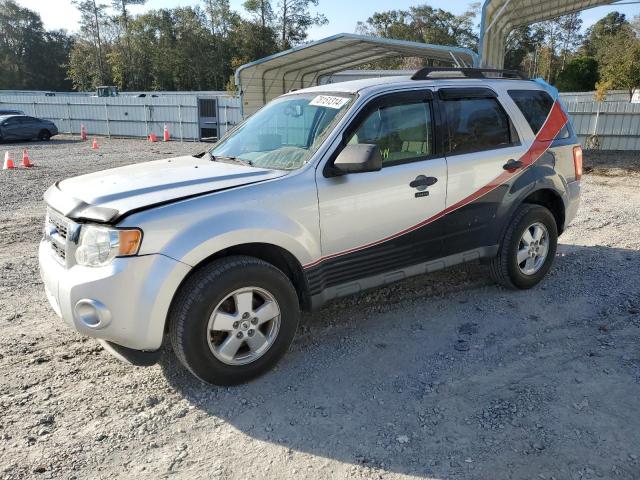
[438,87,526,255]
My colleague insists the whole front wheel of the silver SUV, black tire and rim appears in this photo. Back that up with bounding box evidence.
[169,256,300,385]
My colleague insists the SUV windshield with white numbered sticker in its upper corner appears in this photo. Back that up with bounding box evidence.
[211,92,353,170]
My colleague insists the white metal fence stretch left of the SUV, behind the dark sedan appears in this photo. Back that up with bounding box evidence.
[0,92,242,140]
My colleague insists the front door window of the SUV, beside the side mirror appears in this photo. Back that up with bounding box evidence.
[347,101,433,165]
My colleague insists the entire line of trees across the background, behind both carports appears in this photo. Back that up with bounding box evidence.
[0,0,640,92]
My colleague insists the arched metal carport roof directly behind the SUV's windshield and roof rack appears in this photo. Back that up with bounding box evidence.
[236,33,478,117]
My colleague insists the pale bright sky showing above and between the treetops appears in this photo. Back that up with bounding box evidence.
[17,0,640,40]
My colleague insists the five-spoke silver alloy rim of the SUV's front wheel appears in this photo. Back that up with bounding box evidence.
[207,287,280,365]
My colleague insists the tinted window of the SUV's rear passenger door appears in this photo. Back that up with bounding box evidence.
[443,98,518,155]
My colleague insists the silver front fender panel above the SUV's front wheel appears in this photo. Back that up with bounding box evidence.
[120,175,321,266]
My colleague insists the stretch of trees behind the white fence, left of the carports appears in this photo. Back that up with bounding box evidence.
[0,0,327,91]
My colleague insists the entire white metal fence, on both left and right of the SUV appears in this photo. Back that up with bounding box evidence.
[0,88,640,150]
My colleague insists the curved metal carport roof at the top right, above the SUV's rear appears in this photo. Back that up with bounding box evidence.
[480,0,615,68]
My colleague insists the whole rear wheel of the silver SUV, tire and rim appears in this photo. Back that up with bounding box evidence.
[489,203,558,290]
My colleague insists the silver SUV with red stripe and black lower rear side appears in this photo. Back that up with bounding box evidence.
[39,68,582,385]
